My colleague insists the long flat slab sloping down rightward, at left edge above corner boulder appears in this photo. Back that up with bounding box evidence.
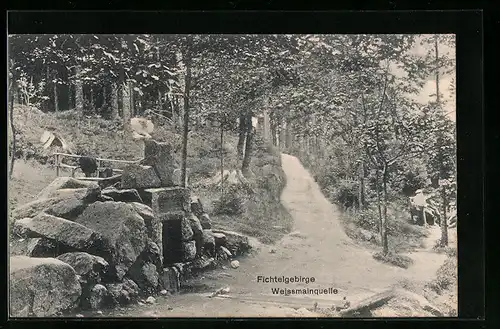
[14,213,100,250]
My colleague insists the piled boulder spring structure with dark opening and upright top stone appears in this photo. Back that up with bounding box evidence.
[9,140,250,316]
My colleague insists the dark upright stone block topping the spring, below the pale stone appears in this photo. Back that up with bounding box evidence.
[143,139,175,186]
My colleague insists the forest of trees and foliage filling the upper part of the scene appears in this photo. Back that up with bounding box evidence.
[8,34,456,254]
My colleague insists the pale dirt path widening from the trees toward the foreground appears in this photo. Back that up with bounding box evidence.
[108,155,446,317]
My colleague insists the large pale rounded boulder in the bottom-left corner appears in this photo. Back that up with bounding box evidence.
[9,256,82,317]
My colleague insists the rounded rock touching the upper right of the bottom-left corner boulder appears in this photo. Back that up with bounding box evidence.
[57,252,109,283]
